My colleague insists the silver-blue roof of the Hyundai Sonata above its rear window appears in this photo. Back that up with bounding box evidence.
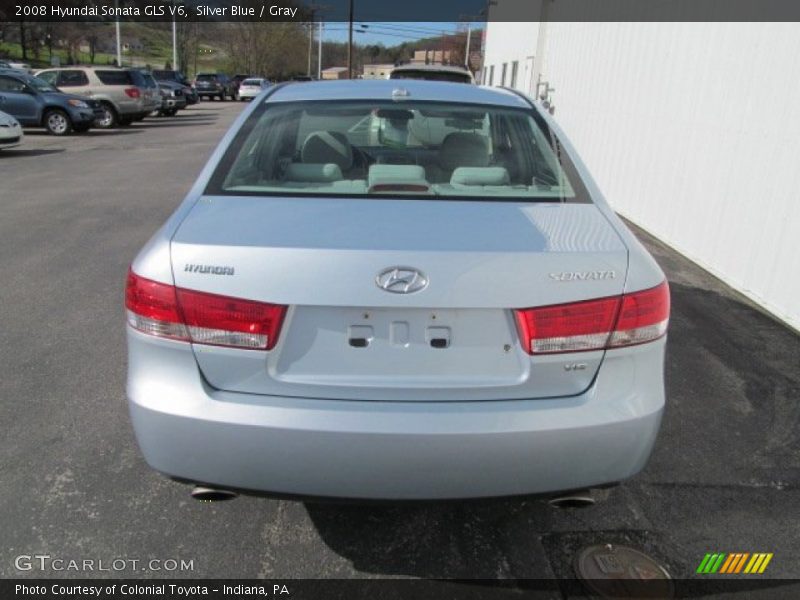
[267,79,531,108]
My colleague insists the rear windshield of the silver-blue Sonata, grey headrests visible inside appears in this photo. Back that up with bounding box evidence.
[207,101,588,202]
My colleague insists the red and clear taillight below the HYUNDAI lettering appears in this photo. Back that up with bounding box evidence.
[125,271,286,350]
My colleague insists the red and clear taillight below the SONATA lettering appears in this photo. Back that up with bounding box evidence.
[515,281,669,354]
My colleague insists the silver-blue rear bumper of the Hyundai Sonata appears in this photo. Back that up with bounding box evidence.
[127,329,665,499]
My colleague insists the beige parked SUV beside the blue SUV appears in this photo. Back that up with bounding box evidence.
[36,66,161,129]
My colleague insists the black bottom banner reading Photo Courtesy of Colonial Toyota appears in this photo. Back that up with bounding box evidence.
[0,577,800,600]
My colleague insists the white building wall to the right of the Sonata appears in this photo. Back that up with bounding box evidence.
[486,21,800,329]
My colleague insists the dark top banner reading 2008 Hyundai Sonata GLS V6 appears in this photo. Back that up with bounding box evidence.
[0,0,800,23]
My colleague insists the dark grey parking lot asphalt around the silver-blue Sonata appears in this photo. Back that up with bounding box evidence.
[0,102,800,597]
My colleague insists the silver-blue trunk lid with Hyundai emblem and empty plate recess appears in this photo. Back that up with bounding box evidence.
[172,196,627,401]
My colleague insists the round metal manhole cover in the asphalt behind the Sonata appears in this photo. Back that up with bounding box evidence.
[575,544,675,598]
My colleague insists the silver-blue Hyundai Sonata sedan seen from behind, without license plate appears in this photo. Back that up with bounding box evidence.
[126,81,669,499]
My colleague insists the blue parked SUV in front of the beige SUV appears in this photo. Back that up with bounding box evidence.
[0,69,103,135]
